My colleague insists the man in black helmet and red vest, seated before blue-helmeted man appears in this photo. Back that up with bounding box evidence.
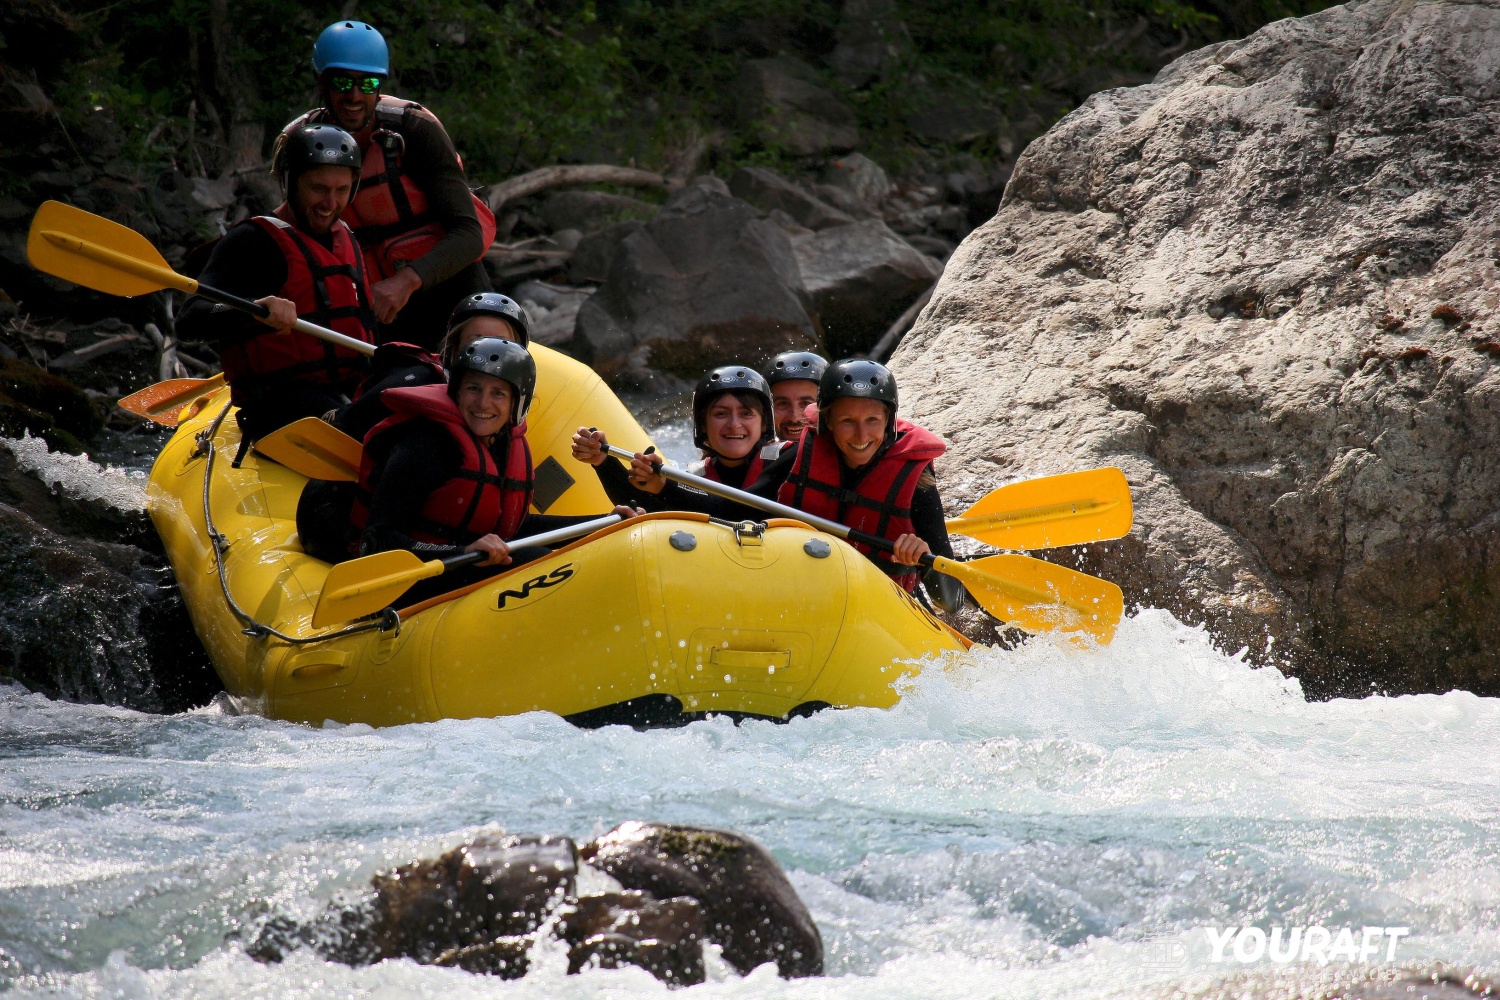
[177,124,375,444]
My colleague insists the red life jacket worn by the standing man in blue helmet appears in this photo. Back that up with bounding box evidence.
[282,97,495,282]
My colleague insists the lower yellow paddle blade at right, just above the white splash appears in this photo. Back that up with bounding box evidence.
[933,555,1125,643]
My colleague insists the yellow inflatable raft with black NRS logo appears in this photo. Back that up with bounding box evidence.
[150,346,968,726]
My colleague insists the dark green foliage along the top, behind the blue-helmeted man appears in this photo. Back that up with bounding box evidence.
[41,0,1328,183]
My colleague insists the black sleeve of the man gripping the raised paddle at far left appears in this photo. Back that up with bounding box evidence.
[177,225,287,348]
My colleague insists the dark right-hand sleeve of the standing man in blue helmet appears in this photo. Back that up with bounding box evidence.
[401,114,485,288]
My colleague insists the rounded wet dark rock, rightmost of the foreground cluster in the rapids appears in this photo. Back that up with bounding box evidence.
[579,822,824,978]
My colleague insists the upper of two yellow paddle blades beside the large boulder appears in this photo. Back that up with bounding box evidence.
[948,468,1134,549]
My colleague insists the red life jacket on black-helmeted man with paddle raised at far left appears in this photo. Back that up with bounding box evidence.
[221,202,375,405]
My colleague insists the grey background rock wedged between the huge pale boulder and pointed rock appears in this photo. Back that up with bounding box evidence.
[792,219,942,357]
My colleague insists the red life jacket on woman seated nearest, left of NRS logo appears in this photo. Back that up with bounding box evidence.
[350,385,533,546]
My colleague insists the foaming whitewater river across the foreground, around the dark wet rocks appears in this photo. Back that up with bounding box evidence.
[0,425,1500,1000]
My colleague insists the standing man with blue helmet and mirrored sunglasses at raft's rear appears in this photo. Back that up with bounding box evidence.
[278,21,495,349]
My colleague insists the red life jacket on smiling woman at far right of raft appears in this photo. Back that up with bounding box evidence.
[777,418,947,591]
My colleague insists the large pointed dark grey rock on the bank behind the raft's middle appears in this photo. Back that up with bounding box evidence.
[575,181,819,384]
